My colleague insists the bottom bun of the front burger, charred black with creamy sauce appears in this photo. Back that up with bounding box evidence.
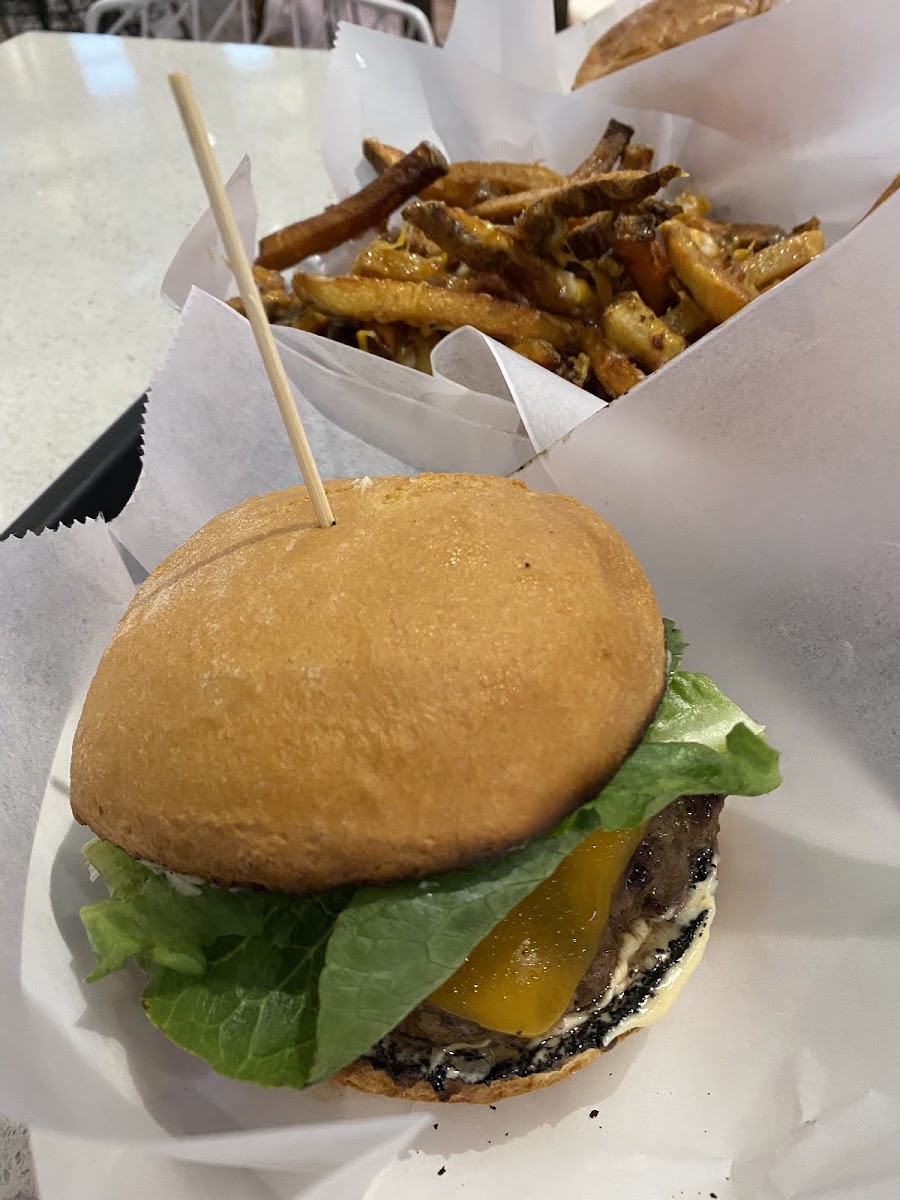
[332,860,718,1104]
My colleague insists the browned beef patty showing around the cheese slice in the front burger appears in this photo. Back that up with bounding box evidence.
[366,796,725,1099]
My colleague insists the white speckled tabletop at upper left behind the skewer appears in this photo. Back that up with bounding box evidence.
[0,34,330,529]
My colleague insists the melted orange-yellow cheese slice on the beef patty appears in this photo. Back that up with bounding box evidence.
[430,827,643,1038]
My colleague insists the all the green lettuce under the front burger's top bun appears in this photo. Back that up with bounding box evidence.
[82,624,780,1087]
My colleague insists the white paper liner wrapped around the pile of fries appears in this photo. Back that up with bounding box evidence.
[163,0,900,482]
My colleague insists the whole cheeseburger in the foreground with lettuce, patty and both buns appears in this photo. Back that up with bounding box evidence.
[71,475,779,1103]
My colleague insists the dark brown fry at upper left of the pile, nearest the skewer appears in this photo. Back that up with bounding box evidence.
[257,142,448,270]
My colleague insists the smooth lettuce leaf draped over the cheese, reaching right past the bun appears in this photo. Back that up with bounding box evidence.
[312,672,781,1080]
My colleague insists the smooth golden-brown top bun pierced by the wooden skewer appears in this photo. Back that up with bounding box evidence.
[71,475,665,892]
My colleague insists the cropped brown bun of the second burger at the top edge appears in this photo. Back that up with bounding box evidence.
[572,0,772,88]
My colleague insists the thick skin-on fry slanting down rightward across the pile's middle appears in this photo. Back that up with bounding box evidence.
[403,200,593,314]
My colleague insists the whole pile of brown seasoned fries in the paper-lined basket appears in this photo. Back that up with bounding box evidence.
[243,120,835,400]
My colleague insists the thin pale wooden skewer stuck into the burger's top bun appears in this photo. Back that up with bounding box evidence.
[169,71,335,528]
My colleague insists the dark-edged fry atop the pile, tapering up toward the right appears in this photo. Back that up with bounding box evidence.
[516,163,684,251]
